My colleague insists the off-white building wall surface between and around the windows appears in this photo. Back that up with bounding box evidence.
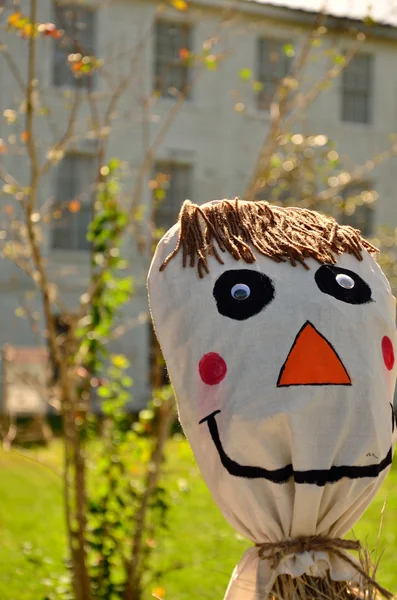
[0,0,397,406]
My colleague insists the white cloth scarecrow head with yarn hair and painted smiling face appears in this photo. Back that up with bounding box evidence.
[148,199,397,600]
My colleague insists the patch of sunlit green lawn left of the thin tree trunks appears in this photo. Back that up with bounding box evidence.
[0,452,65,600]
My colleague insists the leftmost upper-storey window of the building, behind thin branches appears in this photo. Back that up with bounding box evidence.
[52,3,96,89]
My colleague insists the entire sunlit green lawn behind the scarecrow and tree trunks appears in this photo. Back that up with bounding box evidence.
[0,440,397,600]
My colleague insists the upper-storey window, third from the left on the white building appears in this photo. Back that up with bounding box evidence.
[257,38,292,110]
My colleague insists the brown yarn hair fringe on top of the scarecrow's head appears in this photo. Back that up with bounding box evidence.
[160,198,379,278]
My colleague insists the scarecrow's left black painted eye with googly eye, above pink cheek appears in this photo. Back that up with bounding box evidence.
[213,269,275,321]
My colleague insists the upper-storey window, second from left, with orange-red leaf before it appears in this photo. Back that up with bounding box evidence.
[154,21,191,98]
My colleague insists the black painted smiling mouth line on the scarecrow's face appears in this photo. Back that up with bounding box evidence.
[200,406,395,487]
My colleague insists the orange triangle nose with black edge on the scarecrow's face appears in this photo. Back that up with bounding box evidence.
[277,321,351,387]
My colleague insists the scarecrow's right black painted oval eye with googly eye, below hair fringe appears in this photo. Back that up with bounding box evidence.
[314,265,373,304]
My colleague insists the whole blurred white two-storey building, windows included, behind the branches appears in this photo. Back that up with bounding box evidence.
[0,0,397,406]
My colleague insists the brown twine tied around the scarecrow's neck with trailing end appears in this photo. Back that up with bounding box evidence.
[256,535,393,600]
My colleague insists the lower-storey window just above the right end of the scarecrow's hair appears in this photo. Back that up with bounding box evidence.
[336,182,376,236]
